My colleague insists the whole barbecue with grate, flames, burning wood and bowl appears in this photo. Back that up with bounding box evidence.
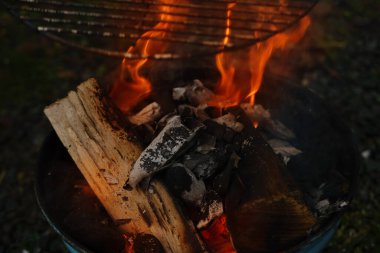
[2,0,357,253]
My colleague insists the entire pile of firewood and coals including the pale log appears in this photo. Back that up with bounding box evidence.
[45,79,354,252]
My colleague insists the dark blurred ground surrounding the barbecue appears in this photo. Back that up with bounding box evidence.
[0,0,380,253]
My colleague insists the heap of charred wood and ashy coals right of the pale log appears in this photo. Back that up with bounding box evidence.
[125,80,349,252]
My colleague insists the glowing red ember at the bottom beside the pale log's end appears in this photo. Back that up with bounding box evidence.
[201,215,236,253]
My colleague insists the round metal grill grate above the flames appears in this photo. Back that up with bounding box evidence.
[0,0,317,59]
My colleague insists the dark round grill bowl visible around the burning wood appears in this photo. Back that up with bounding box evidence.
[35,79,360,253]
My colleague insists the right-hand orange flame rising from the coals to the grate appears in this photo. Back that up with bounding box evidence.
[208,8,310,108]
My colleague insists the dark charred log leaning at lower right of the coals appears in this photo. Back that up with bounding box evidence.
[225,109,316,253]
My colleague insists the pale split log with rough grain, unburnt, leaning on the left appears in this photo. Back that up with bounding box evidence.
[44,79,206,253]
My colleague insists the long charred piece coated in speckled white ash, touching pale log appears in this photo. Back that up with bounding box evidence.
[127,116,203,187]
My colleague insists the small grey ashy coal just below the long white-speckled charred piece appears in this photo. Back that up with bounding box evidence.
[181,167,206,205]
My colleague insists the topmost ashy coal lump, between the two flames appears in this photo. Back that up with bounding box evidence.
[172,79,215,106]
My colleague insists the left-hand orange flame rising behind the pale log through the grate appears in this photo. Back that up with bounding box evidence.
[110,0,184,113]
